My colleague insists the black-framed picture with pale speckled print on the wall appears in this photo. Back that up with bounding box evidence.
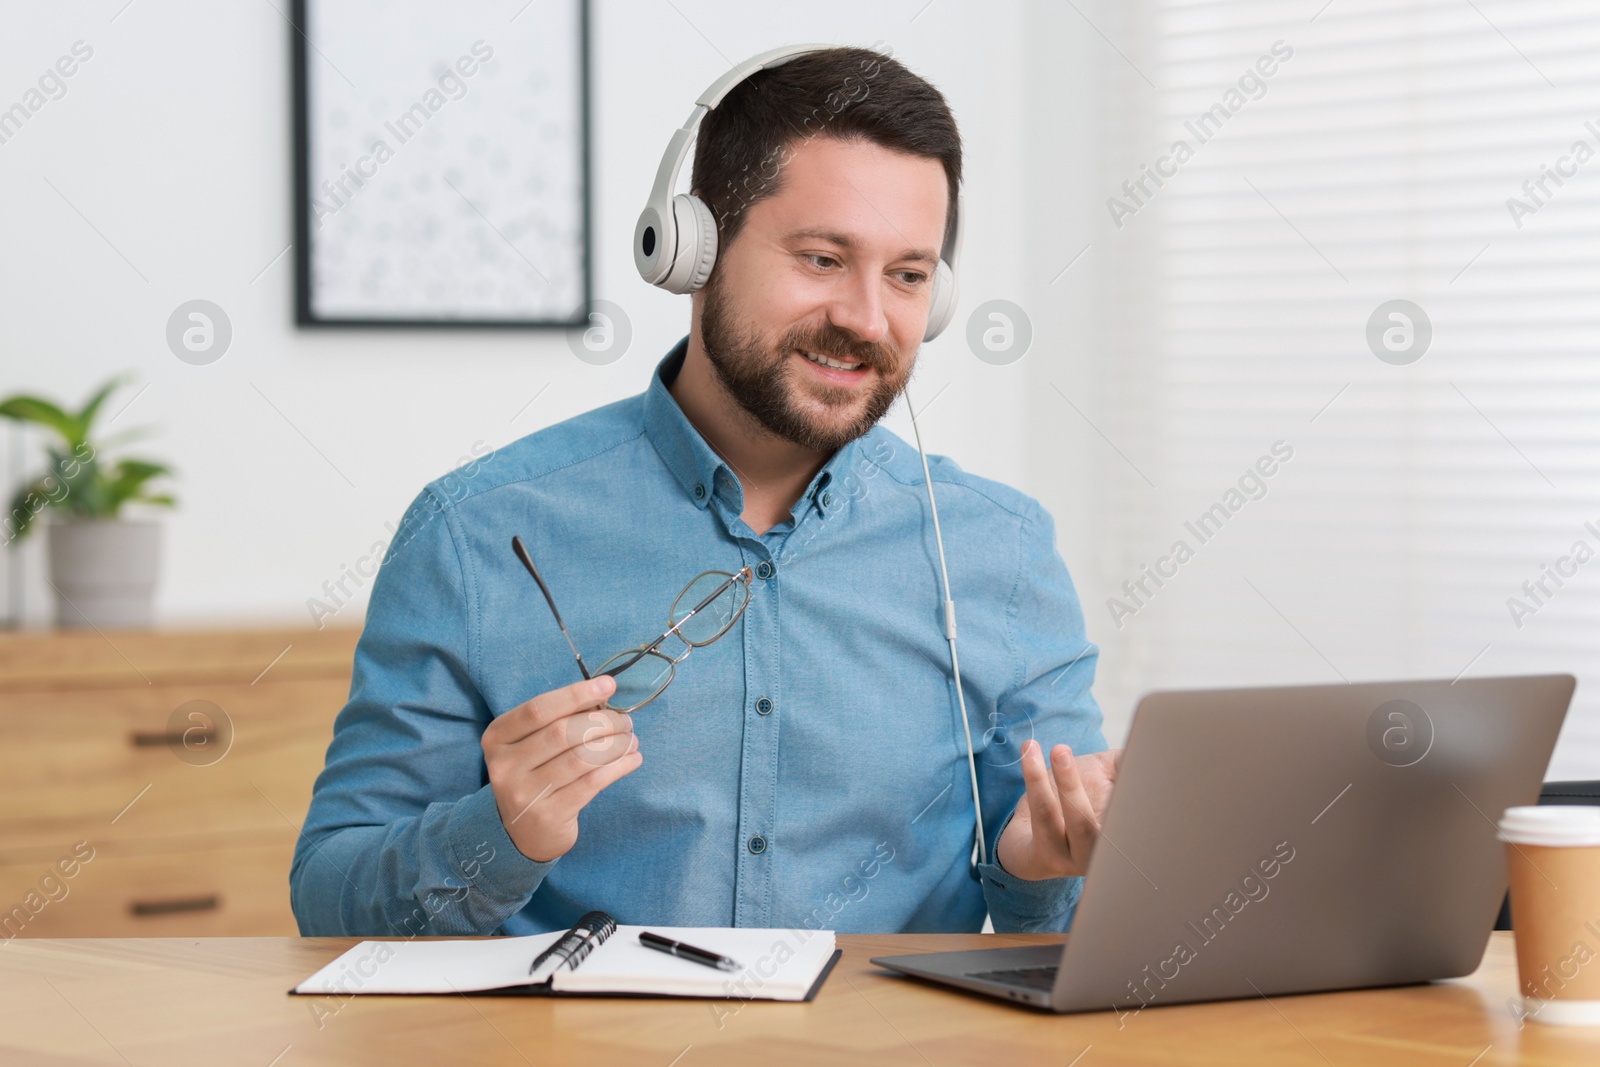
[291,0,590,326]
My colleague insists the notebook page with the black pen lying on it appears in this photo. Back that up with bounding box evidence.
[552,926,834,1000]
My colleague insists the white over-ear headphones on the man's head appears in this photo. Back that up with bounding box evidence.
[634,45,962,341]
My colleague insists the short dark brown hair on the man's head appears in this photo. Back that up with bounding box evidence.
[691,48,962,265]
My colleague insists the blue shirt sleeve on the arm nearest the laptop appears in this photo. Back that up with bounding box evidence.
[978,504,1106,933]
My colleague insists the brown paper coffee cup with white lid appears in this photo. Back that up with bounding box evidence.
[1499,805,1600,1027]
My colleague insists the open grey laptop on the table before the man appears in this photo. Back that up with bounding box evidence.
[872,675,1576,1013]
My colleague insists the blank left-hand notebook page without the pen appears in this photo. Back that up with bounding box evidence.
[294,931,566,995]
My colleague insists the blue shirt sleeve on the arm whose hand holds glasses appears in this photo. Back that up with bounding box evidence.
[290,486,558,936]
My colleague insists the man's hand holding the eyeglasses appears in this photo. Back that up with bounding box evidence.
[483,675,645,862]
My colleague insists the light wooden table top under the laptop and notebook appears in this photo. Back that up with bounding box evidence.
[0,934,1600,1067]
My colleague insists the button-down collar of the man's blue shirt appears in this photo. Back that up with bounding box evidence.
[645,338,858,520]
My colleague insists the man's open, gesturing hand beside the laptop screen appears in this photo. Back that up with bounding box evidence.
[995,741,1122,881]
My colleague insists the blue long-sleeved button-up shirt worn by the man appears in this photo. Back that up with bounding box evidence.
[290,341,1106,936]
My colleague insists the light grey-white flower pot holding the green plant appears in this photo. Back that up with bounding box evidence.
[46,514,162,630]
